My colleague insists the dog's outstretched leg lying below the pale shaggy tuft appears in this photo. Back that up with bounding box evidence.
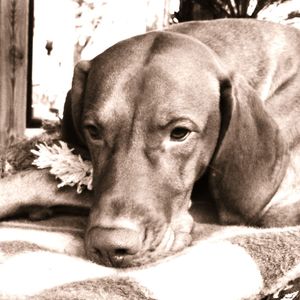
[0,170,91,219]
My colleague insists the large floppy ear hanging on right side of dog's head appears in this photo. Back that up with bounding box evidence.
[208,76,288,224]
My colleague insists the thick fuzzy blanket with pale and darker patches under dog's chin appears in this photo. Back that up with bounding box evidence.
[0,125,300,300]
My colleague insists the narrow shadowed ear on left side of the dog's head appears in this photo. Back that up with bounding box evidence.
[62,61,91,146]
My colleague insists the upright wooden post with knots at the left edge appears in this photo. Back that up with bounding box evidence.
[0,0,29,146]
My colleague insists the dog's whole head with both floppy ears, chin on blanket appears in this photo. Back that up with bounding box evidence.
[63,32,284,267]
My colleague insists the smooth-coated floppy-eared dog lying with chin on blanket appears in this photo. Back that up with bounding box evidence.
[0,19,300,267]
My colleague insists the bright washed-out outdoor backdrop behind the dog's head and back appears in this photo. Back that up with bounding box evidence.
[32,0,299,123]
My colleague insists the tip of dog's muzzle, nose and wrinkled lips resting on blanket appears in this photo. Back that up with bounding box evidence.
[85,213,193,268]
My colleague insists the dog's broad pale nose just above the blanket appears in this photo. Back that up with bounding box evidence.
[89,227,142,267]
